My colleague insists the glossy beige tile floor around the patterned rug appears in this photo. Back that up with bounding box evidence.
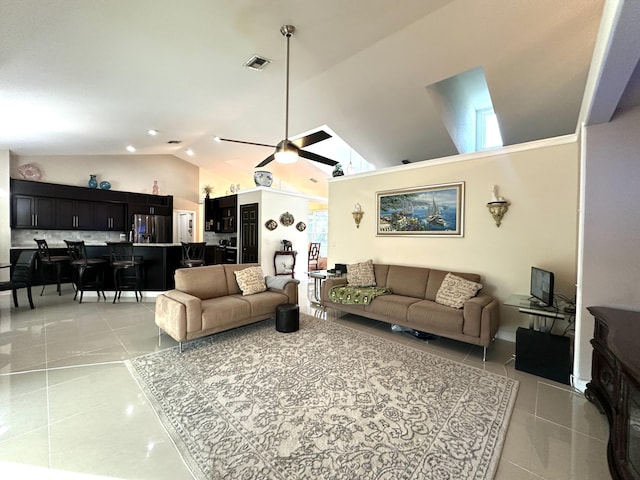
[0,285,611,480]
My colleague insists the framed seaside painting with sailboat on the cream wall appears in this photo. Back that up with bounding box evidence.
[376,182,464,237]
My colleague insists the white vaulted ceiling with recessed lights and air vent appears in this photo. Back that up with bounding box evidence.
[0,0,604,194]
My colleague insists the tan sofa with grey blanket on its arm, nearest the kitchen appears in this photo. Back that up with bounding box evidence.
[155,264,299,351]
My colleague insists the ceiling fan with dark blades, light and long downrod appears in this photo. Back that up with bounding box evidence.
[216,25,338,168]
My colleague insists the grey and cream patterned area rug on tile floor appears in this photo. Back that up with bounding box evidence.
[127,315,518,480]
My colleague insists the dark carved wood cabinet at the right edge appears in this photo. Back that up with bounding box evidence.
[585,307,640,480]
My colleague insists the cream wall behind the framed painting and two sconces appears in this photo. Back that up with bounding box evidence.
[328,136,579,340]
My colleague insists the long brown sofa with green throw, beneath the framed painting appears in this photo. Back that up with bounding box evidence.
[321,264,500,360]
